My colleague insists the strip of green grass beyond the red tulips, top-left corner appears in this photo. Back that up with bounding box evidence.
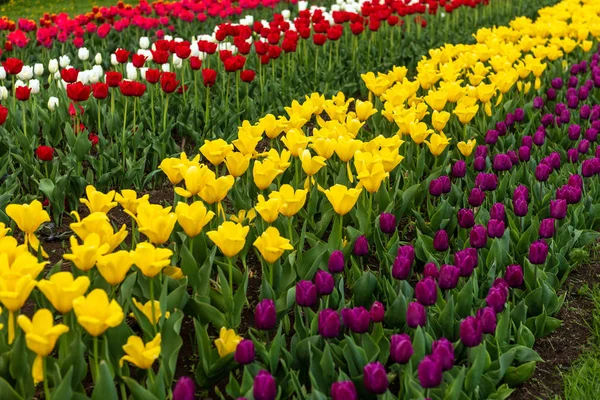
[0,0,137,22]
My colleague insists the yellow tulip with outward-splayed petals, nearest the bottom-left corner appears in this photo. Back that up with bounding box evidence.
[17,308,69,383]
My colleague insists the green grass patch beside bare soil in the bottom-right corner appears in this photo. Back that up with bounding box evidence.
[563,286,600,400]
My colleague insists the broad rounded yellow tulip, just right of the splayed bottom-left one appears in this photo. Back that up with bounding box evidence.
[73,289,124,337]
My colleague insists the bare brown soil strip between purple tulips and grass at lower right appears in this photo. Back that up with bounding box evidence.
[509,263,600,400]
